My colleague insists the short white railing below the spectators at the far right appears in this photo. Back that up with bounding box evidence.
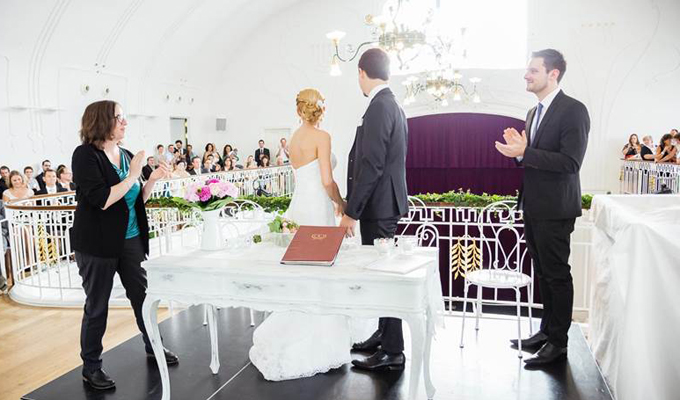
[619,160,680,194]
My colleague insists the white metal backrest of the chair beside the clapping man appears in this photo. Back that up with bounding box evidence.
[477,200,527,272]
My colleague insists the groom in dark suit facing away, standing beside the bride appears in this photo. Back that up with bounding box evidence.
[340,48,408,371]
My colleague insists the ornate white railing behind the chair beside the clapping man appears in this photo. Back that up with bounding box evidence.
[398,197,592,319]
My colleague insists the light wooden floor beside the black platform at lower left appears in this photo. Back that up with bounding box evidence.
[0,296,169,399]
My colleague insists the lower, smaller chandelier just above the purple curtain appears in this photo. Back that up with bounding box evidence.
[402,69,482,107]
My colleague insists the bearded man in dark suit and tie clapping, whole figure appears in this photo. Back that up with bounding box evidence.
[496,49,590,366]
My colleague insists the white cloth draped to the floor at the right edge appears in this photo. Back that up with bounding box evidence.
[589,195,680,400]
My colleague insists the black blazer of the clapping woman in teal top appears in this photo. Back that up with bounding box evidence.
[71,144,149,258]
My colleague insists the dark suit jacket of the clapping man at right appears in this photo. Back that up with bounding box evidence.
[519,91,590,220]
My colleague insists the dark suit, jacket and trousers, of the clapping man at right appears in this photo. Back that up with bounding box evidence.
[519,91,590,348]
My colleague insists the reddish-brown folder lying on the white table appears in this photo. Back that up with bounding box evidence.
[281,225,346,267]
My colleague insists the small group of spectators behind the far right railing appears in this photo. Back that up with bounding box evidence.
[621,129,680,164]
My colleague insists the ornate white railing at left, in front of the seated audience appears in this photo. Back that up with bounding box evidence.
[0,166,295,306]
